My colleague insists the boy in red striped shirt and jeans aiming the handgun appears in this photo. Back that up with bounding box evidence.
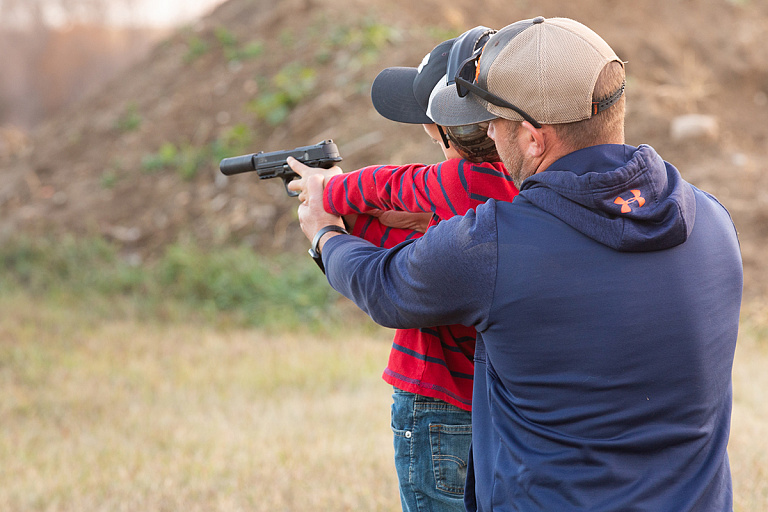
[289,27,517,512]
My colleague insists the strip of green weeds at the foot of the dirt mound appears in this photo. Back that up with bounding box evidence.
[0,236,363,330]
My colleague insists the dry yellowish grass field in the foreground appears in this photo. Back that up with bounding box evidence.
[0,296,768,512]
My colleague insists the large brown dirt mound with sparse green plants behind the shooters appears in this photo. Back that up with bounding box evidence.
[0,0,768,295]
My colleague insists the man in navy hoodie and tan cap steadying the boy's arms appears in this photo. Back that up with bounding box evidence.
[292,18,743,512]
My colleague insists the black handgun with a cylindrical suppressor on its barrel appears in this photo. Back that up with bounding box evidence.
[219,139,341,197]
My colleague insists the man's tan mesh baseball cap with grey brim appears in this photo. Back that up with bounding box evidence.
[429,17,624,126]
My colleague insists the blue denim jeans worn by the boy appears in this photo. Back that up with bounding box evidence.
[392,388,472,512]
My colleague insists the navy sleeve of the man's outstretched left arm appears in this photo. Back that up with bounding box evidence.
[323,201,498,329]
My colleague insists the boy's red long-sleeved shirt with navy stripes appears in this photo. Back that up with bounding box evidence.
[324,159,518,410]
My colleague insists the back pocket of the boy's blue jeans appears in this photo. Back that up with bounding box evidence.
[429,424,472,496]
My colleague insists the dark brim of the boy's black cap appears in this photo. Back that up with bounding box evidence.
[371,67,434,124]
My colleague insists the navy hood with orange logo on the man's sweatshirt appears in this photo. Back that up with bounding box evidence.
[520,144,696,252]
